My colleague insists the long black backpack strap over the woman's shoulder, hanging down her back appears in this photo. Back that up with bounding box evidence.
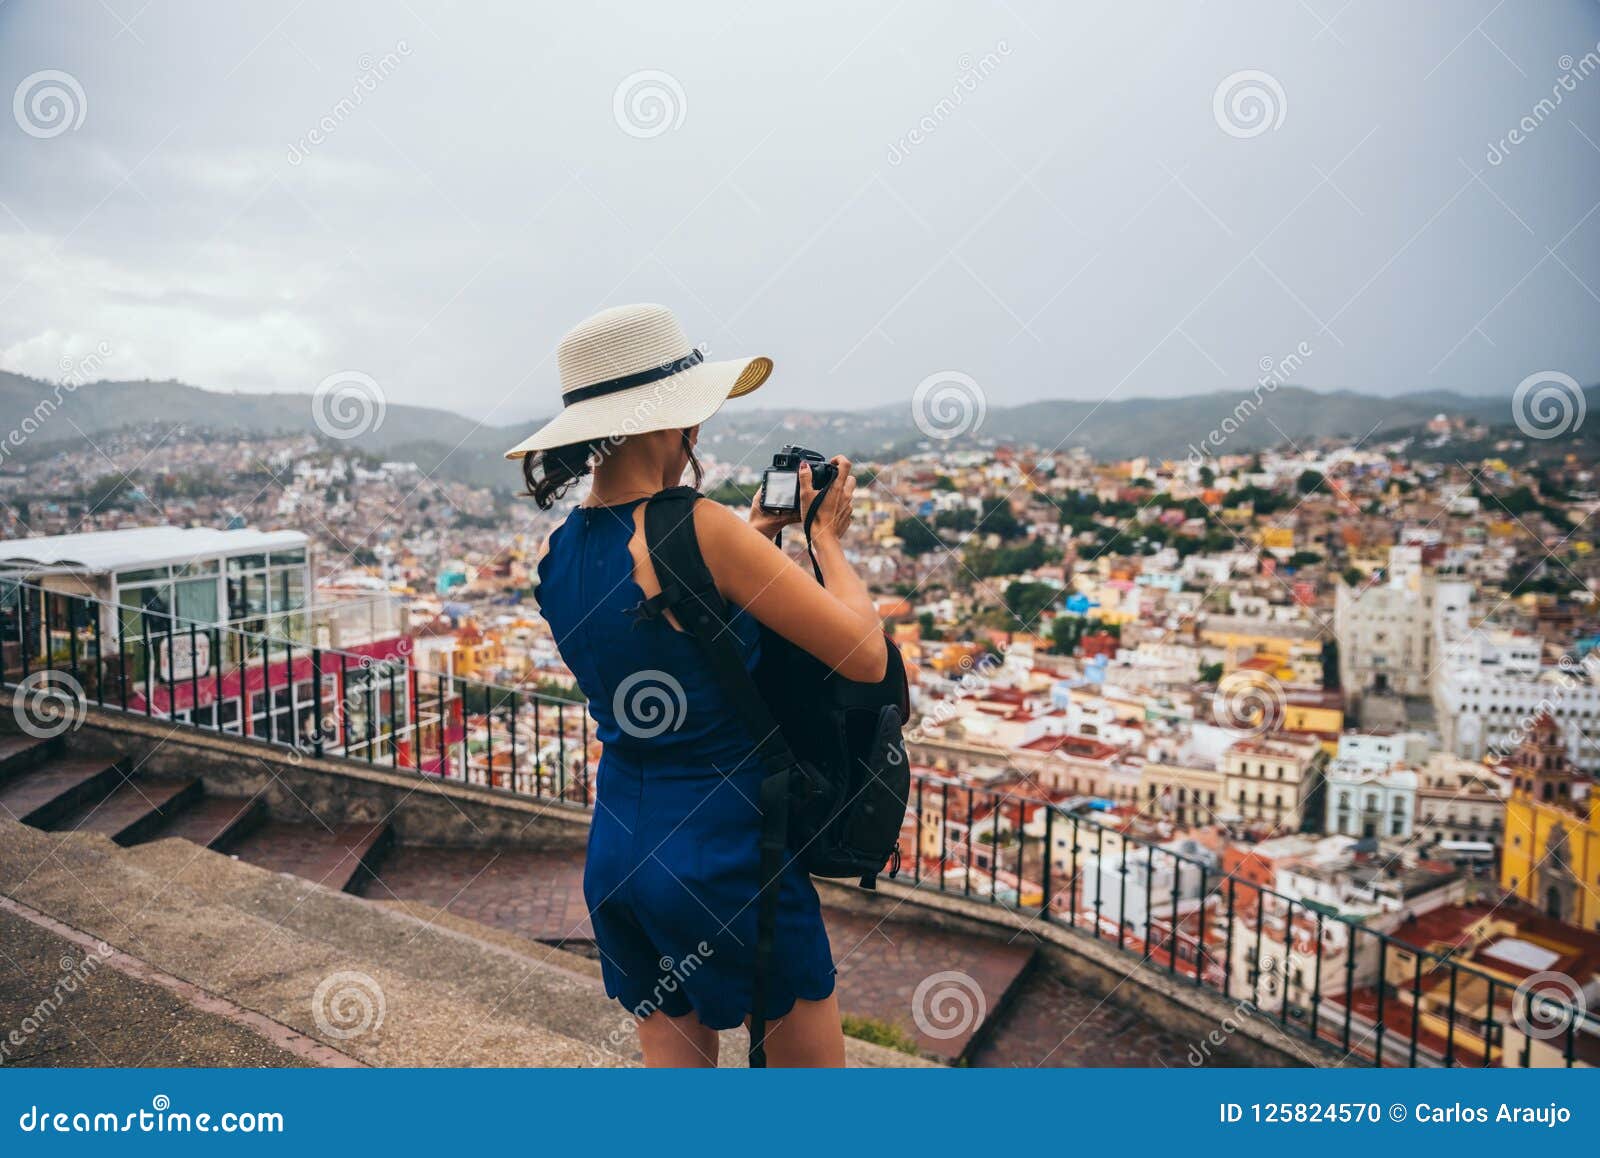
[638,486,795,1068]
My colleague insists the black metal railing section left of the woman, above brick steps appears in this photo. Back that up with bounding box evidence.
[0,582,594,805]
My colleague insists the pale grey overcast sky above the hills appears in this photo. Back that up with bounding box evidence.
[0,0,1600,422]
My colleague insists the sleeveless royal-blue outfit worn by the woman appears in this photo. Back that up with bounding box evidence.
[538,499,834,1030]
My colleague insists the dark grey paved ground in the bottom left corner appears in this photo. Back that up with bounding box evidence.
[0,912,307,1067]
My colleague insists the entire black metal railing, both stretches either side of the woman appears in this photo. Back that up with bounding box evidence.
[0,584,1600,1067]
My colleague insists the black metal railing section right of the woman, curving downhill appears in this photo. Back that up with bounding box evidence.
[901,776,1600,1067]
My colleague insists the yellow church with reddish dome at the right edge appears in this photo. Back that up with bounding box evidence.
[1501,712,1600,929]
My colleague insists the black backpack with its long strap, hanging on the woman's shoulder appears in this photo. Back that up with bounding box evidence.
[640,486,910,1067]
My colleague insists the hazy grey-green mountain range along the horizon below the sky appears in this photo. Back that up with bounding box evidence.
[0,371,1600,486]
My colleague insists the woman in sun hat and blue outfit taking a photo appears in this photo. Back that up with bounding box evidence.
[507,305,888,1065]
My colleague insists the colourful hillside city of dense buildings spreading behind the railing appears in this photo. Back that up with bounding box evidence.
[0,397,1600,1067]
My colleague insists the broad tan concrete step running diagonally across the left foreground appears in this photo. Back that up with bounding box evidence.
[0,821,627,1067]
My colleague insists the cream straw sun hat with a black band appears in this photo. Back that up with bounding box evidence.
[506,305,773,459]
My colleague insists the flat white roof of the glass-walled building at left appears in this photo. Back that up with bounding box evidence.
[0,526,309,574]
